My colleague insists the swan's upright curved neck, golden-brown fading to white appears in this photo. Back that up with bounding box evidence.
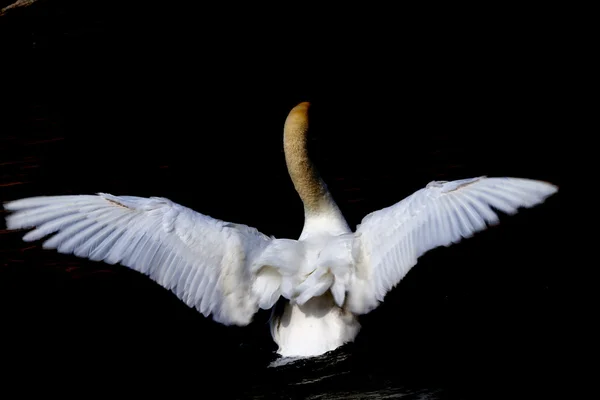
[283,103,349,238]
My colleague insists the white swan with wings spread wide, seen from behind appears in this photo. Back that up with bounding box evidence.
[4,102,558,357]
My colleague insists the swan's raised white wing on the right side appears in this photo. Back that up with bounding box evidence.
[346,177,558,314]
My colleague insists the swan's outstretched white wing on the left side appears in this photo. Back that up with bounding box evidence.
[4,193,301,325]
